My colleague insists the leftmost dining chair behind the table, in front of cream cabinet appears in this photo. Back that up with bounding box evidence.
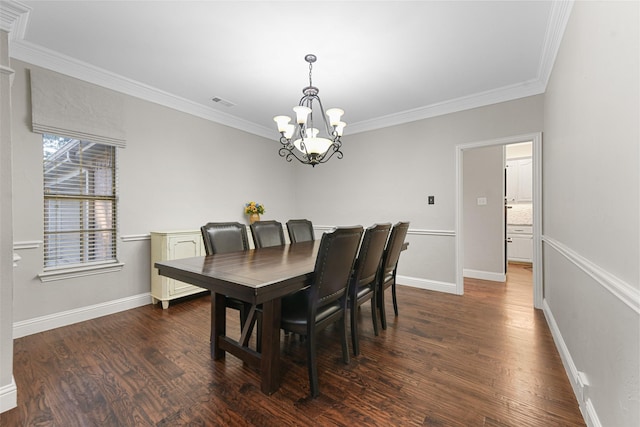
[200,222,260,347]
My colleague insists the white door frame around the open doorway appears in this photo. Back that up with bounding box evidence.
[455,132,544,309]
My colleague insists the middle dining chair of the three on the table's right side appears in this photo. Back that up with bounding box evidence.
[349,223,391,356]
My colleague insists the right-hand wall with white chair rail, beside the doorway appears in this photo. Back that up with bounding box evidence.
[543,2,640,426]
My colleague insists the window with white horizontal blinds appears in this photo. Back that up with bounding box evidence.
[42,134,117,270]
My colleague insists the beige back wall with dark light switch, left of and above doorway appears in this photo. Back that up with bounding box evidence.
[296,95,543,292]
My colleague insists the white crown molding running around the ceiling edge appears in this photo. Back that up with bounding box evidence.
[1,0,574,140]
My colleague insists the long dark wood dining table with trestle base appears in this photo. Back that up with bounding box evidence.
[154,240,320,395]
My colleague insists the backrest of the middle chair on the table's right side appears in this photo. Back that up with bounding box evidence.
[352,223,391,296]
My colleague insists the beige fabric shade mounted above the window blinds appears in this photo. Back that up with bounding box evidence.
[31,68,126,147]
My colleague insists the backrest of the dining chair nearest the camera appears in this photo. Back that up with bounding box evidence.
[309,226,363,315]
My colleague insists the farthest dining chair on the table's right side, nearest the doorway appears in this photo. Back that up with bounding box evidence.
[376,222,409,329]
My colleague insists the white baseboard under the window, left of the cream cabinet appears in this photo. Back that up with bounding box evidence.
[13,293,151,339]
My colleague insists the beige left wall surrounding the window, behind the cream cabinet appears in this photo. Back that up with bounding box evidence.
[12,60,296,327]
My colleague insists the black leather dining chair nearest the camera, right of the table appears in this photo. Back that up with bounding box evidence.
[280,226,363,397]
